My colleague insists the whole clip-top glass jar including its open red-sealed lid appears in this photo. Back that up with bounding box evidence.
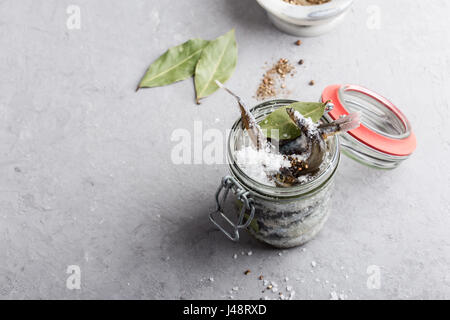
[210,85,416,248]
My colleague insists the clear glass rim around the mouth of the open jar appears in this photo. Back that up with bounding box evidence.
[227,99,340,199]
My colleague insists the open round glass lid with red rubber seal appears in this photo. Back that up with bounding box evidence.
[322,85,416,169]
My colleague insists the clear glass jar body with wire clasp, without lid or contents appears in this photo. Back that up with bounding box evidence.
[210,100,340,248]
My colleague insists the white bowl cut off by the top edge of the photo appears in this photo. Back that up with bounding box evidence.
[256,0,353,37]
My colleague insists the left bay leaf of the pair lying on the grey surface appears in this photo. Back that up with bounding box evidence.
[137,39,209,90]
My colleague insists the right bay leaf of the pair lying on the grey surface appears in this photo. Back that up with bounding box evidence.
[195,29,237,103]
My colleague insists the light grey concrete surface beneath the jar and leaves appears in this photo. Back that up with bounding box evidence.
[0,0,450,299]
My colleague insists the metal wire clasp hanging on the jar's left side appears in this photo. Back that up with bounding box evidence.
[209,176,255,241]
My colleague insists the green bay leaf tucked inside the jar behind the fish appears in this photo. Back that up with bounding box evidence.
[259,102,326,140]
